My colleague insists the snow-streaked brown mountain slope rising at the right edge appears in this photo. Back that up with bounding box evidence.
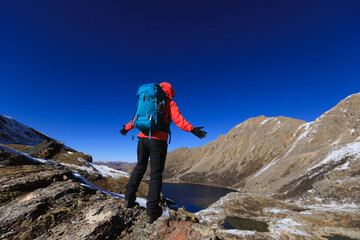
[241,93,360,202]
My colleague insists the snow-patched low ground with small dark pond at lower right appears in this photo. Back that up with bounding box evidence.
[196,192,360,240]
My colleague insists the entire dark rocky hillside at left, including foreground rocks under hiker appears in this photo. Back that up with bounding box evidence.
[0,115,218,240]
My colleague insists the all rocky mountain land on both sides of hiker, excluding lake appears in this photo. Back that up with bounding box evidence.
[0,93,360,240]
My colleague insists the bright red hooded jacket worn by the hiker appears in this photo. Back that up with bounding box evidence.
[125,82,194,141]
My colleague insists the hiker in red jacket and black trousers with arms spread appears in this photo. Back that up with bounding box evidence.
[120,82,207,223]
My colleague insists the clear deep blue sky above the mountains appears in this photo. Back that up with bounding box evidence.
[0,0,360,161]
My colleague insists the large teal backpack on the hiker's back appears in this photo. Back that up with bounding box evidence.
[131,83,168,139]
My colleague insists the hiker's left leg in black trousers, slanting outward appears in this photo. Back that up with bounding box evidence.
[125,138,150,203]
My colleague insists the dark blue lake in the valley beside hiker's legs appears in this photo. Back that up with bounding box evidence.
[162,183,235,213]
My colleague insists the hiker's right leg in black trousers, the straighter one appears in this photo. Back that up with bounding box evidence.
[146,139,167,217]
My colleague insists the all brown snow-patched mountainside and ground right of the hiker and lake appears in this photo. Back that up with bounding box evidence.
[166,93,360,240]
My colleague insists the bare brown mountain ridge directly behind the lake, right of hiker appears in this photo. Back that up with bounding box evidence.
[164,116,305,188]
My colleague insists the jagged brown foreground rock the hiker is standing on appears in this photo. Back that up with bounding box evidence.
[0,143,222,240]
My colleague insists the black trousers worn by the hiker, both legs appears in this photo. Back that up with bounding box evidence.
[125,138,167,215]
